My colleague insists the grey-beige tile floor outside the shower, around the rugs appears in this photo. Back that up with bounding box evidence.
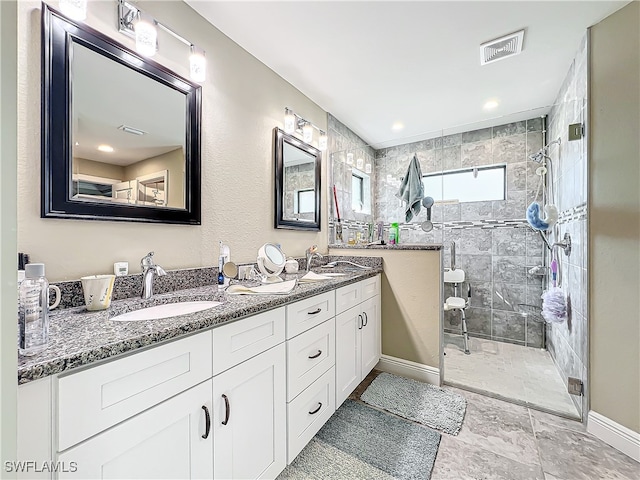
[351,371,640,480]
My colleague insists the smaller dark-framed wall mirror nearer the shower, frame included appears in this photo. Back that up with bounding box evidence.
[273,127,322,231]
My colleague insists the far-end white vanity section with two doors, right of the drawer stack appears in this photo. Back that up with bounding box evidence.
[336,276,381,408]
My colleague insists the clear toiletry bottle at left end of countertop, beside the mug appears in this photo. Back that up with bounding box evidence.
[18,263,49,355]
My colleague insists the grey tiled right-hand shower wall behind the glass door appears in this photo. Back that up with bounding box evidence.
[547,35,588,414]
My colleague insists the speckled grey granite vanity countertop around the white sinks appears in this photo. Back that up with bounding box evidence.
[18,264,382,384]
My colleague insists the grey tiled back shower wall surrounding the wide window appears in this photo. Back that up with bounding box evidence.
[375,118,544,347]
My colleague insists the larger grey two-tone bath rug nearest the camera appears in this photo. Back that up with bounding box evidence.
[278,400,440,480]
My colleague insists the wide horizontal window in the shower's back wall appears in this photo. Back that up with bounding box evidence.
[422,165,507,203]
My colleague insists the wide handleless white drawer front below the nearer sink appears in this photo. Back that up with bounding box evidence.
[58,331,211,451]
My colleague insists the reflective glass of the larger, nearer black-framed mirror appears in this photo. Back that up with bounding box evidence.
[70,42,186,209]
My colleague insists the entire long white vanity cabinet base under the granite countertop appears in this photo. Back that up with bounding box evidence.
[18,276,380,479]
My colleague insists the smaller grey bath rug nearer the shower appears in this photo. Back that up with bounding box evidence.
[360,372,467,435]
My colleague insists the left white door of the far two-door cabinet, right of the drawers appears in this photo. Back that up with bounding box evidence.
[336,305,363,408]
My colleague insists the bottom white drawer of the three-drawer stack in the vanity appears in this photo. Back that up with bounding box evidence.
[287,368,336,464]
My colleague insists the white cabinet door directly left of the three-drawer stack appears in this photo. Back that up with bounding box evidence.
[212,343,287,479]
